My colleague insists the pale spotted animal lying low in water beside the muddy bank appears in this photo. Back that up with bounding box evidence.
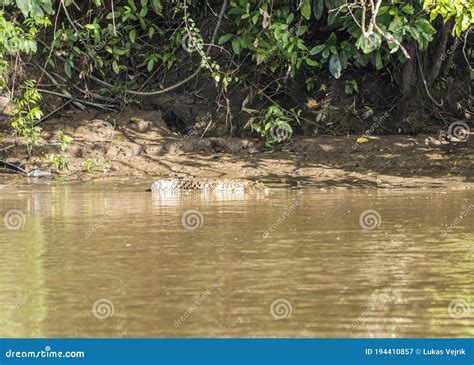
[151,177,268,193]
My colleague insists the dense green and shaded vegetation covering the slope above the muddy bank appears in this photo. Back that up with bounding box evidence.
[0,0,474,151]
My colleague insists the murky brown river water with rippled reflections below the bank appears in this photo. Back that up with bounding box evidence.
[0,182,474,337]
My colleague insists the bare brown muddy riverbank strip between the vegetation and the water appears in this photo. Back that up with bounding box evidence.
[0,111,474,189]
